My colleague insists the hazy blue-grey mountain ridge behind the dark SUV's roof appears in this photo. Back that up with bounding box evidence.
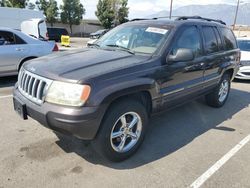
[148,3,250,25]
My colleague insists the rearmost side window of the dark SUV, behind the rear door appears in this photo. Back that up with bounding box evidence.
[221,27,237,50]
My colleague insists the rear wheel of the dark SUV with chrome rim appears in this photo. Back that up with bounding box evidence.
[206,74,231,108]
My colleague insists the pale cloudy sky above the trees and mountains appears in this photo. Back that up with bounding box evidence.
[32,0,250,19]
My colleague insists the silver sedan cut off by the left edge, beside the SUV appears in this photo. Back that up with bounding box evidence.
[0,27,58,77]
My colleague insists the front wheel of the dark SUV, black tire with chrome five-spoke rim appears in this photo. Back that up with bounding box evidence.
[92,99,148,162]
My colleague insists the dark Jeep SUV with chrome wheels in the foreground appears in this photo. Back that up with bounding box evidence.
[13,17,240,161]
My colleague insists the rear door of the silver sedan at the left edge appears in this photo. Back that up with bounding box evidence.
[0,31,28,73]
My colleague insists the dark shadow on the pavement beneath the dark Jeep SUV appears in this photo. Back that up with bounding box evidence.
[57,86,250,169]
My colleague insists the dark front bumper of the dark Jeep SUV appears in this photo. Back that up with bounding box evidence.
[13,87,106,140]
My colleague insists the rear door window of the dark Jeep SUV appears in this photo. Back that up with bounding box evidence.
[202,26,219,54]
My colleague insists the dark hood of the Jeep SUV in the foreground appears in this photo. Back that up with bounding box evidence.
[24,48,149,81]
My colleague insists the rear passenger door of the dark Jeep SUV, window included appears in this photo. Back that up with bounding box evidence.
[201,26,225,87]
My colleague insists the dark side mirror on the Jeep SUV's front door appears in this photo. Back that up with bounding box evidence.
[167,48,194,62]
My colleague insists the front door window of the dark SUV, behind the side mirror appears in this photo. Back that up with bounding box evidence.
[172,26,202,57]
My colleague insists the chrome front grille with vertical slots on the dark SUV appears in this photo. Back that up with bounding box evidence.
[18,68,52,104]
